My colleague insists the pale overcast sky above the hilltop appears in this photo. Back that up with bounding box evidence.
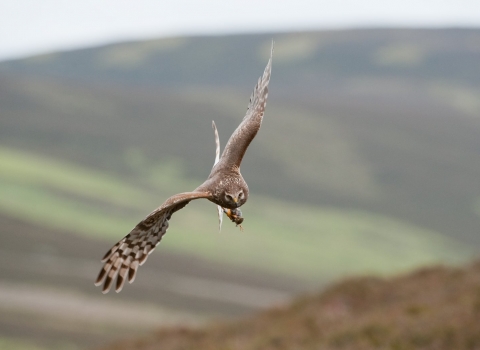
[0,0,480,60]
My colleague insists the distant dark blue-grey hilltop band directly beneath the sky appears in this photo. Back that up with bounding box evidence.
[0,29,480,92]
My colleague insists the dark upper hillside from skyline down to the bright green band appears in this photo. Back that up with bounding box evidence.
[0,29,480,245]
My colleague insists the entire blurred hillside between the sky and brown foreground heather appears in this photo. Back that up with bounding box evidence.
[0,29,480,349]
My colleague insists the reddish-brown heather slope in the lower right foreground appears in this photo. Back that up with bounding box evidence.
[101,261,480,350]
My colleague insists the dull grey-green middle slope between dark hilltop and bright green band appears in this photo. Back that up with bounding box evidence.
[0,65,480,249]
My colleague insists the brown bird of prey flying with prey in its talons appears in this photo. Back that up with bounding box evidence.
[95,43,273,293]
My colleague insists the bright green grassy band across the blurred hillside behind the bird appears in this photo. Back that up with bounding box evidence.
[0,148,472,283]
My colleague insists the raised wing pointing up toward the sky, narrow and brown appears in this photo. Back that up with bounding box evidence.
[218,42,273,168]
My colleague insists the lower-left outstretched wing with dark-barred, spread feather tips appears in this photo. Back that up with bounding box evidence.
[95,192,211,293]
